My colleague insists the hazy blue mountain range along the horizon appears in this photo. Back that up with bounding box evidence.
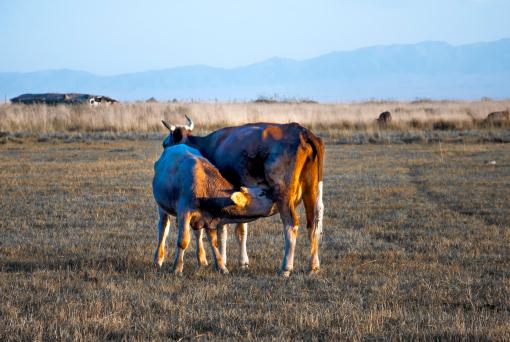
[0,39,510,101]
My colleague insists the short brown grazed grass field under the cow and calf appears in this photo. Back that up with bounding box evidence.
[0,136,510,341]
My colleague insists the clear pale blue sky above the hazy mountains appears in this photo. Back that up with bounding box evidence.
[0,0,510,75]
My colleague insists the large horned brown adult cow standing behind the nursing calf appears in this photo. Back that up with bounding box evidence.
[163,118,324,276]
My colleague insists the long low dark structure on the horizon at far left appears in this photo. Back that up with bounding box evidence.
[11,93,117,106]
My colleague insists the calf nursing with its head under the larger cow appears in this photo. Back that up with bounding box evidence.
[152,145,275,274]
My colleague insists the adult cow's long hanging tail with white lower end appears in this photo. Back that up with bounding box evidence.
[300,132,324,237]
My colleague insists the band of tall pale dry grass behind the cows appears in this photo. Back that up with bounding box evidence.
[0,100,510,135]
